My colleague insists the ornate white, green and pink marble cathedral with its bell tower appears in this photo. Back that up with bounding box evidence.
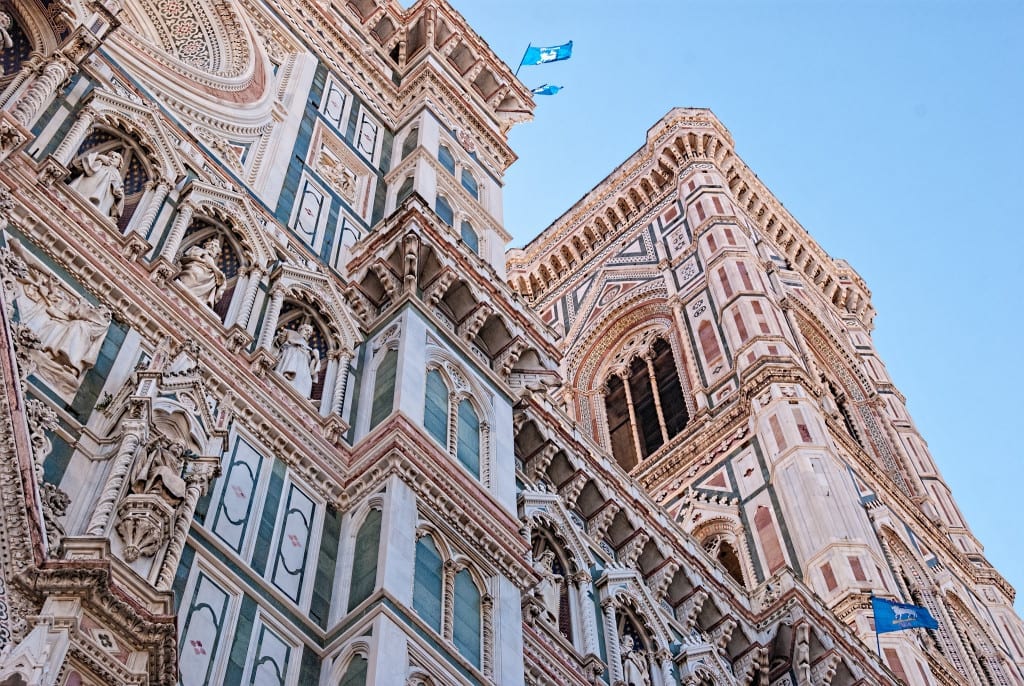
[0,0,1024,686]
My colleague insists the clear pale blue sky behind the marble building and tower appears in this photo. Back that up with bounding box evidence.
[452,0,1024,609]
